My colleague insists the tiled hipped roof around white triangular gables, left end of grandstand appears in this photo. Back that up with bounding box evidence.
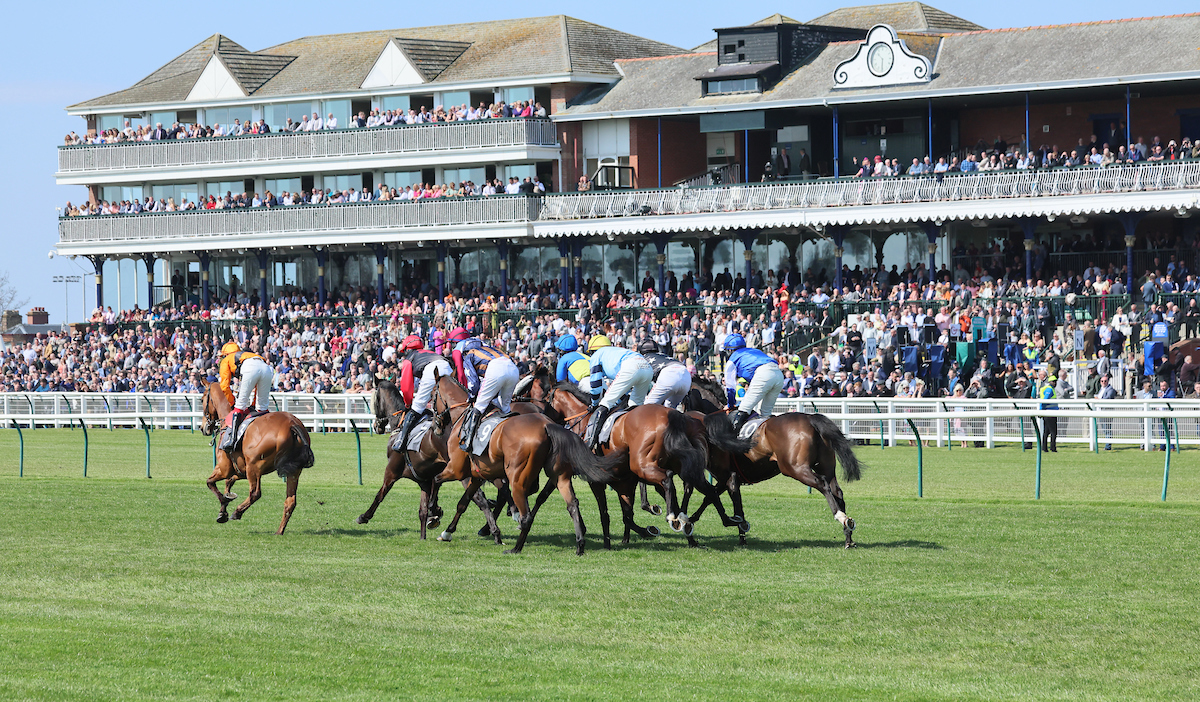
[71,14,684,109]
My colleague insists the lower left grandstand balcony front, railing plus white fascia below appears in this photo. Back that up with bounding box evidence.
[58,196,541,254]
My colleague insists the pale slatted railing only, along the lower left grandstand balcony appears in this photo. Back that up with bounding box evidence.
[59,196,541,244]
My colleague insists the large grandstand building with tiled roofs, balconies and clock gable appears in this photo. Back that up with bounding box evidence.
[56,2,1200,307]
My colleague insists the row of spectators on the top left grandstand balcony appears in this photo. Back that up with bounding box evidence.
[62,100,546,146]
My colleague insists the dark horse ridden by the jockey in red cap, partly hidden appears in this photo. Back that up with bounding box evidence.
[358,380,518,544]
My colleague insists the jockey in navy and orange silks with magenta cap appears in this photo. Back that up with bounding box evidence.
[441,326,521,452]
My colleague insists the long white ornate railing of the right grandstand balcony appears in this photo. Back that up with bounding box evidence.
[540,161,1200,221]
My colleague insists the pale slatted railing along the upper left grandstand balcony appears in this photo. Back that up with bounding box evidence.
[59,119,558,174]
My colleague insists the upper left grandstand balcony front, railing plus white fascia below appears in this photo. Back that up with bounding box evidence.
[55,119,558,185]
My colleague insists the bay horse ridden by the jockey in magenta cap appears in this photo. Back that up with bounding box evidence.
[431,376,626,556]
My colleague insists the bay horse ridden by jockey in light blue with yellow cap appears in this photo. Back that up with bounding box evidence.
[530,367,750,546]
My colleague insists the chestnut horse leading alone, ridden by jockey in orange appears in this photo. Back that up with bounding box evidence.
[200,383,313,534]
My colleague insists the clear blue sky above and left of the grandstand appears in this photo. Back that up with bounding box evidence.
[0,0,1200,322]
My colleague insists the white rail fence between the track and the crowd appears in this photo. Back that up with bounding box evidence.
[0,392,1200,450]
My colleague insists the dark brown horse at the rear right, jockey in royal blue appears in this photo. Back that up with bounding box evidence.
[692,412,863,548]
